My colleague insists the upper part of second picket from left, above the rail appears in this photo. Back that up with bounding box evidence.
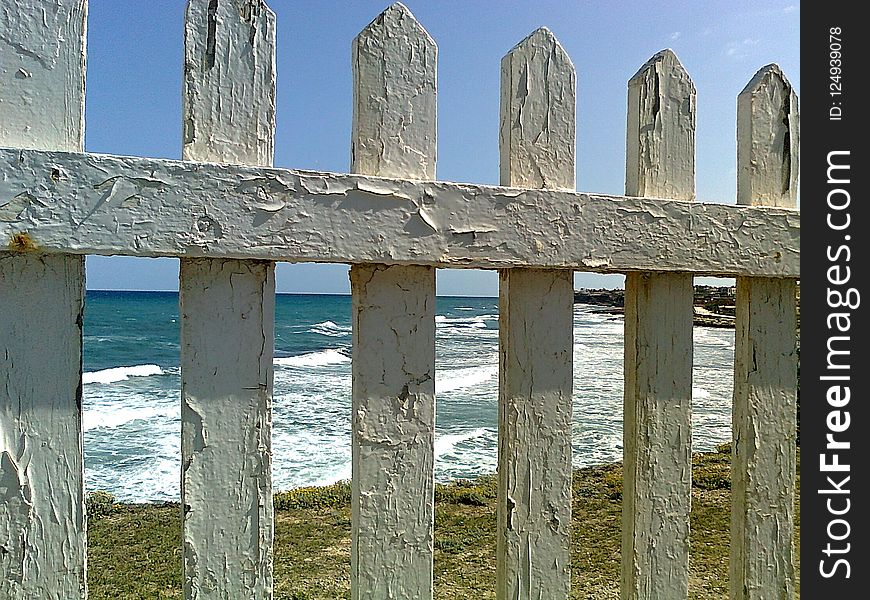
[182,0,275,165]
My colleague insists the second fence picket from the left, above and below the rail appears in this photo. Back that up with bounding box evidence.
[180,0,275,600]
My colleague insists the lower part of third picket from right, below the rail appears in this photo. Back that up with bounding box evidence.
[496,269,582,600]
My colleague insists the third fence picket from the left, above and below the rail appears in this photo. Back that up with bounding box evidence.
[350,3,437,600]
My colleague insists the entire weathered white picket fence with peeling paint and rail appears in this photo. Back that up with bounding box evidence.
[0,0,800,600]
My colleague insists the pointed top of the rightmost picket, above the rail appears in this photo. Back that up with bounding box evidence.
[737,64,800,208]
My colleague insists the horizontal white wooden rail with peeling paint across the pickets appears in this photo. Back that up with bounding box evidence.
[0,150,800,277]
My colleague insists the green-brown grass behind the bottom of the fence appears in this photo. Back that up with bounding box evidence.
[88,446,800,600]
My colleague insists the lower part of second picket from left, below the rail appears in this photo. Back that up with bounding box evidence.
[180,259,275,600]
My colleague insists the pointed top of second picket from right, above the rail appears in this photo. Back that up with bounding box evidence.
[625,48,696,200]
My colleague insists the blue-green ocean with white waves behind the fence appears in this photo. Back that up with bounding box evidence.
[83,291,734,502]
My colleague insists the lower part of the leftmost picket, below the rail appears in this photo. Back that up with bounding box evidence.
[0,253,86,600]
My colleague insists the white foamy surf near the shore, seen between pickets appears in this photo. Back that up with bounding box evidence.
[83,304,733,501]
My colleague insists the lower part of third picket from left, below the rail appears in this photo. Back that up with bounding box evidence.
[350,265,435,600]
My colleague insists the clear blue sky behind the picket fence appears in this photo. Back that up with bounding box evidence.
[85,0,800,295]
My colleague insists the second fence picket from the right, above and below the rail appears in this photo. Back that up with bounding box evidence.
[621,50,695,600]
